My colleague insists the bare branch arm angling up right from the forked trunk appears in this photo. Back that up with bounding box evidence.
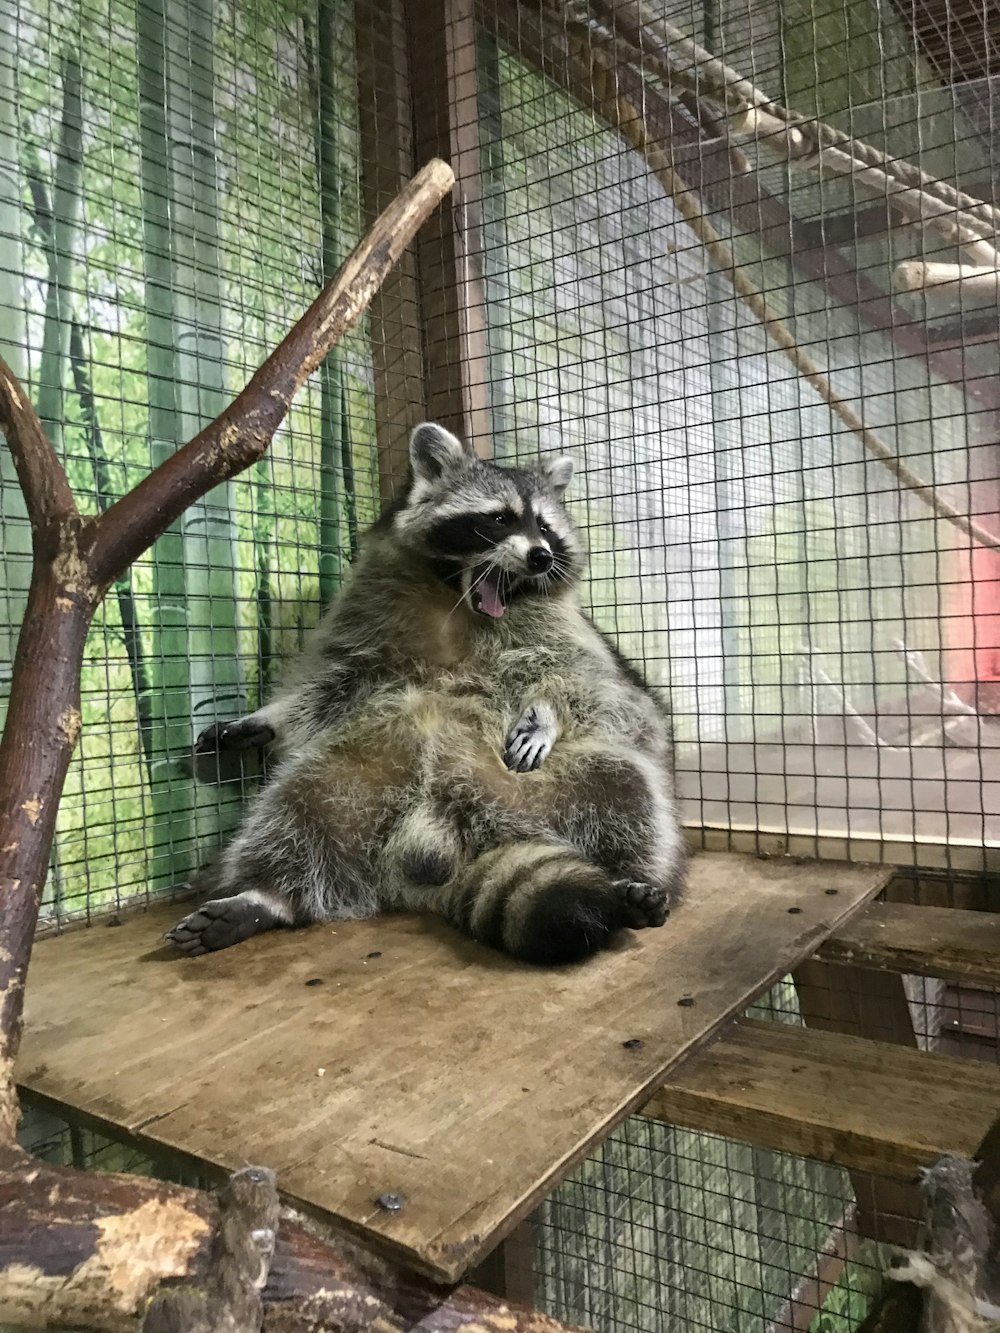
[91,159,455,585]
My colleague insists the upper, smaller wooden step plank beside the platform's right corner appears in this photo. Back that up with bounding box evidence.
[820,902,1000,986]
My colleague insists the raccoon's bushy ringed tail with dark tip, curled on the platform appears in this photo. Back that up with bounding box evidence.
[445,842,669,964]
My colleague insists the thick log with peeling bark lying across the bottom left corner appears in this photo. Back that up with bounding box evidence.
[0,1149,586,1333]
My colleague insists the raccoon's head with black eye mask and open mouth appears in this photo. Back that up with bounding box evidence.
[393,423,583,620]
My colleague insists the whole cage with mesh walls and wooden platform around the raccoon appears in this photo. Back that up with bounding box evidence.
[0,0,1000,1333]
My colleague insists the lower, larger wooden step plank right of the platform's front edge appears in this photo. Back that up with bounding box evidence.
[643,1018,1000,1181]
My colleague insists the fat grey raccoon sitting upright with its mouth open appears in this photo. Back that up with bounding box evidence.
[168,423,684,964]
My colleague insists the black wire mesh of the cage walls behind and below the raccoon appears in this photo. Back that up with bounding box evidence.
[0,0,1000,1333]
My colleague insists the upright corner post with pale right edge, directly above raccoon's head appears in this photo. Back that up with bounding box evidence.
[405,0,489,455]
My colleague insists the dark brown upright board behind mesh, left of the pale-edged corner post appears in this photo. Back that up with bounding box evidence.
[355,0,427,508]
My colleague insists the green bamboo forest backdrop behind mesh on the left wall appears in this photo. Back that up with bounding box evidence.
[0,0,376,916]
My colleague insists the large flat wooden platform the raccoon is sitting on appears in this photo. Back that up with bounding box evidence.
[17,853,892,1281]
